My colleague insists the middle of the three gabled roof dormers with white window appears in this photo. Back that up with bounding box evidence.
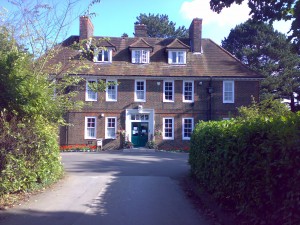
[129,38,153,63]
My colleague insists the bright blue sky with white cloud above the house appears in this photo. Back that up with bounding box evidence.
[0,0,290,44]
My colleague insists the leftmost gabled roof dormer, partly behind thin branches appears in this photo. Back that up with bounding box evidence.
[93,38,116,63]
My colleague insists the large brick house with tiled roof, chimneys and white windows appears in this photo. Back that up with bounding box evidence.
[52,16,261,149]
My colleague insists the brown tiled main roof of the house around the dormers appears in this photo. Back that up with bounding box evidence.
[45,36,262,78]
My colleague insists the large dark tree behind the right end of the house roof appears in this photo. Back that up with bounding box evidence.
[222,20,300,111]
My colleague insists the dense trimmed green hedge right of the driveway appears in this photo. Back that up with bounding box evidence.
[189,114,300,225]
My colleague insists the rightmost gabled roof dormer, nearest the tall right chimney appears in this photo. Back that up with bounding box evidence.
[166,38,190,65]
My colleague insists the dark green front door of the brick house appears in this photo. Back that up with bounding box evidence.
[131,122,148,147]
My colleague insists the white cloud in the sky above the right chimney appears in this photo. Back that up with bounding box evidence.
[180,0,250,28]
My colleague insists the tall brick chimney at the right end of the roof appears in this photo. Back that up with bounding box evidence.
[189,18,202,53]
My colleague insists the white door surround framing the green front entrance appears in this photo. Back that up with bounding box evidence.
[125,109,155,141]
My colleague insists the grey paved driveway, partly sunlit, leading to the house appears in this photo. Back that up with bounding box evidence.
[0,151,208,225]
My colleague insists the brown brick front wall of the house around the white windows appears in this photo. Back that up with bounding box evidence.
[60,79,259,149]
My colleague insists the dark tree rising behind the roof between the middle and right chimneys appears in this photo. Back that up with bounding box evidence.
[135,13,189,38]
